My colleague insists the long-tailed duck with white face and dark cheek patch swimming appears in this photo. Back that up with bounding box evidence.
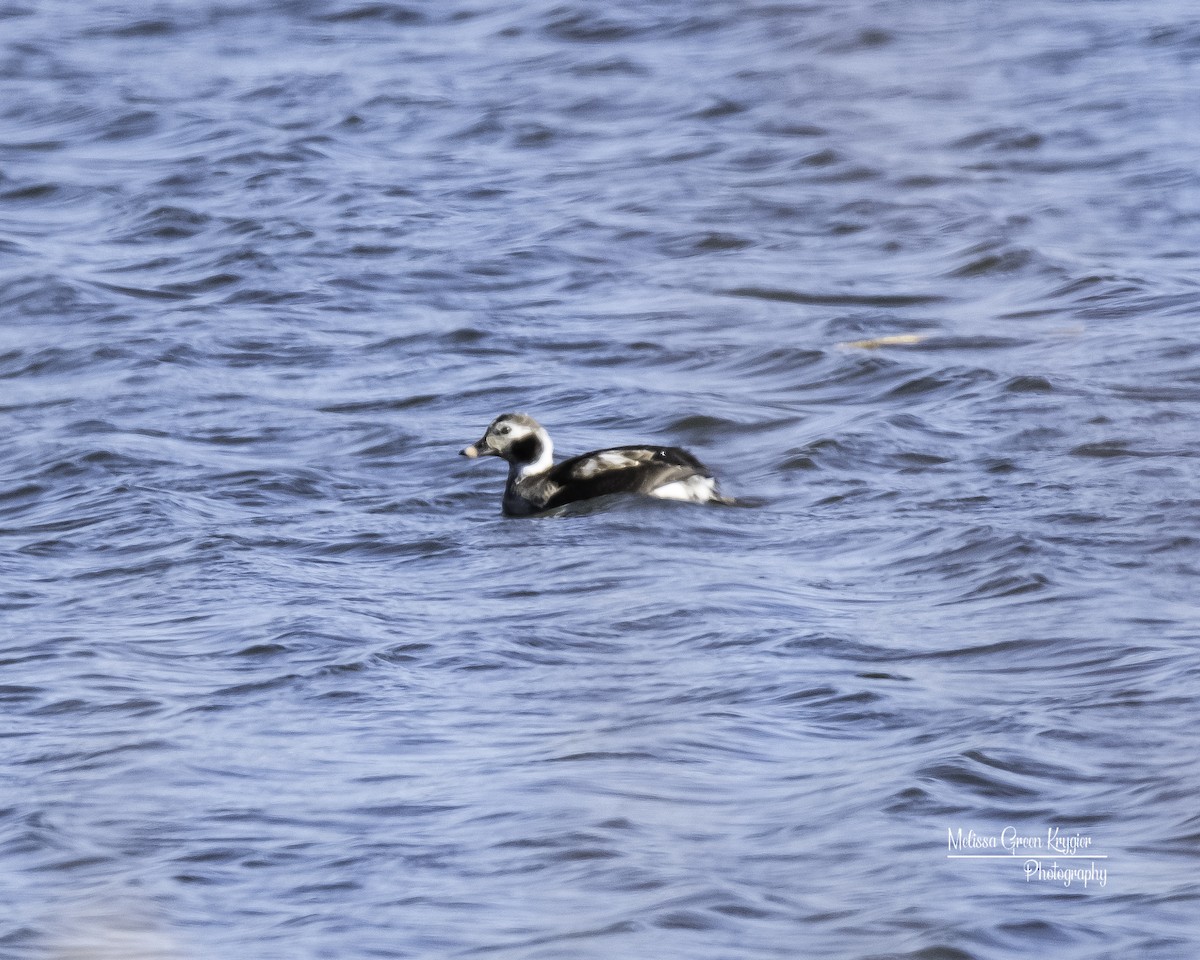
[462,413,732,516]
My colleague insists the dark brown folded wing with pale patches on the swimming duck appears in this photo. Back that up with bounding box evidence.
[544,446,710,509]
